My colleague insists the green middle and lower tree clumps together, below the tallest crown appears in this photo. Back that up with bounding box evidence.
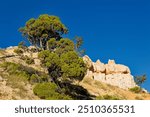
[39,38,86,85]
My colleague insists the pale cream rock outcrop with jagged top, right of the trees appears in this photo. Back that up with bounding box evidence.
[83,55,136,89]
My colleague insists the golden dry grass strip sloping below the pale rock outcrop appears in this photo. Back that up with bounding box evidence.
[80,78,150,100]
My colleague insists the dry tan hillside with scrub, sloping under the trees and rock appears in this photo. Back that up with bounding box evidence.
[0,46,150,100]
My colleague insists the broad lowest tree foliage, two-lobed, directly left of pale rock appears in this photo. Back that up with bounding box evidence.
[39,50,86,80]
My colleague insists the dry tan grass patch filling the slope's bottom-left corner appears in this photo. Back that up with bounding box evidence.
[0,73,39,100]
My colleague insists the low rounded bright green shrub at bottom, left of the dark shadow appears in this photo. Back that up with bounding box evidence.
[33,83,71,100]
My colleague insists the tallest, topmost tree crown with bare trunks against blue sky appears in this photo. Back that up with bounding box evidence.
[19,14,68,49]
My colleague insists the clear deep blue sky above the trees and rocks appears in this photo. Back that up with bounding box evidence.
[0,0,150,91]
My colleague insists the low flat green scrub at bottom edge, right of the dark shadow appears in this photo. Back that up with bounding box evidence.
[96,94,121,100]
